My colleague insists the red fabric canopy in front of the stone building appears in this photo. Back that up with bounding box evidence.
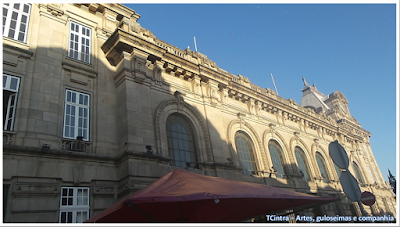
[86,170,337,223]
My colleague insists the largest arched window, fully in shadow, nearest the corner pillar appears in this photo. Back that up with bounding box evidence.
[166,113,197,168]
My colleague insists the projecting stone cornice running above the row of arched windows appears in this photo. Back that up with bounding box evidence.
[102,18,372,140]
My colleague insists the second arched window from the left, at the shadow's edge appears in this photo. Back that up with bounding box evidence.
[235,131,257,175]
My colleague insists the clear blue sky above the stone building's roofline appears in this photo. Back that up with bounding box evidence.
[125,4,398,181]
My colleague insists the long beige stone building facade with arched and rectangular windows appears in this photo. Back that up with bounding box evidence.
[3,3,396,222]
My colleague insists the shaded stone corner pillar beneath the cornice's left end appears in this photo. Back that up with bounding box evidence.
[115,50,155,153]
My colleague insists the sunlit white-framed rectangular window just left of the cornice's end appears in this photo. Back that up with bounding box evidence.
[68,21,92,64]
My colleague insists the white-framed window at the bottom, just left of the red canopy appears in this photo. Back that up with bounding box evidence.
[59,187,90,223]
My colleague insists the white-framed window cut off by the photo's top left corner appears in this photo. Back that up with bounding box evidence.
[3,3,31,43]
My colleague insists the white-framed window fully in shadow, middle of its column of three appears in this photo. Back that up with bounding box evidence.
[63,90,90,141]
